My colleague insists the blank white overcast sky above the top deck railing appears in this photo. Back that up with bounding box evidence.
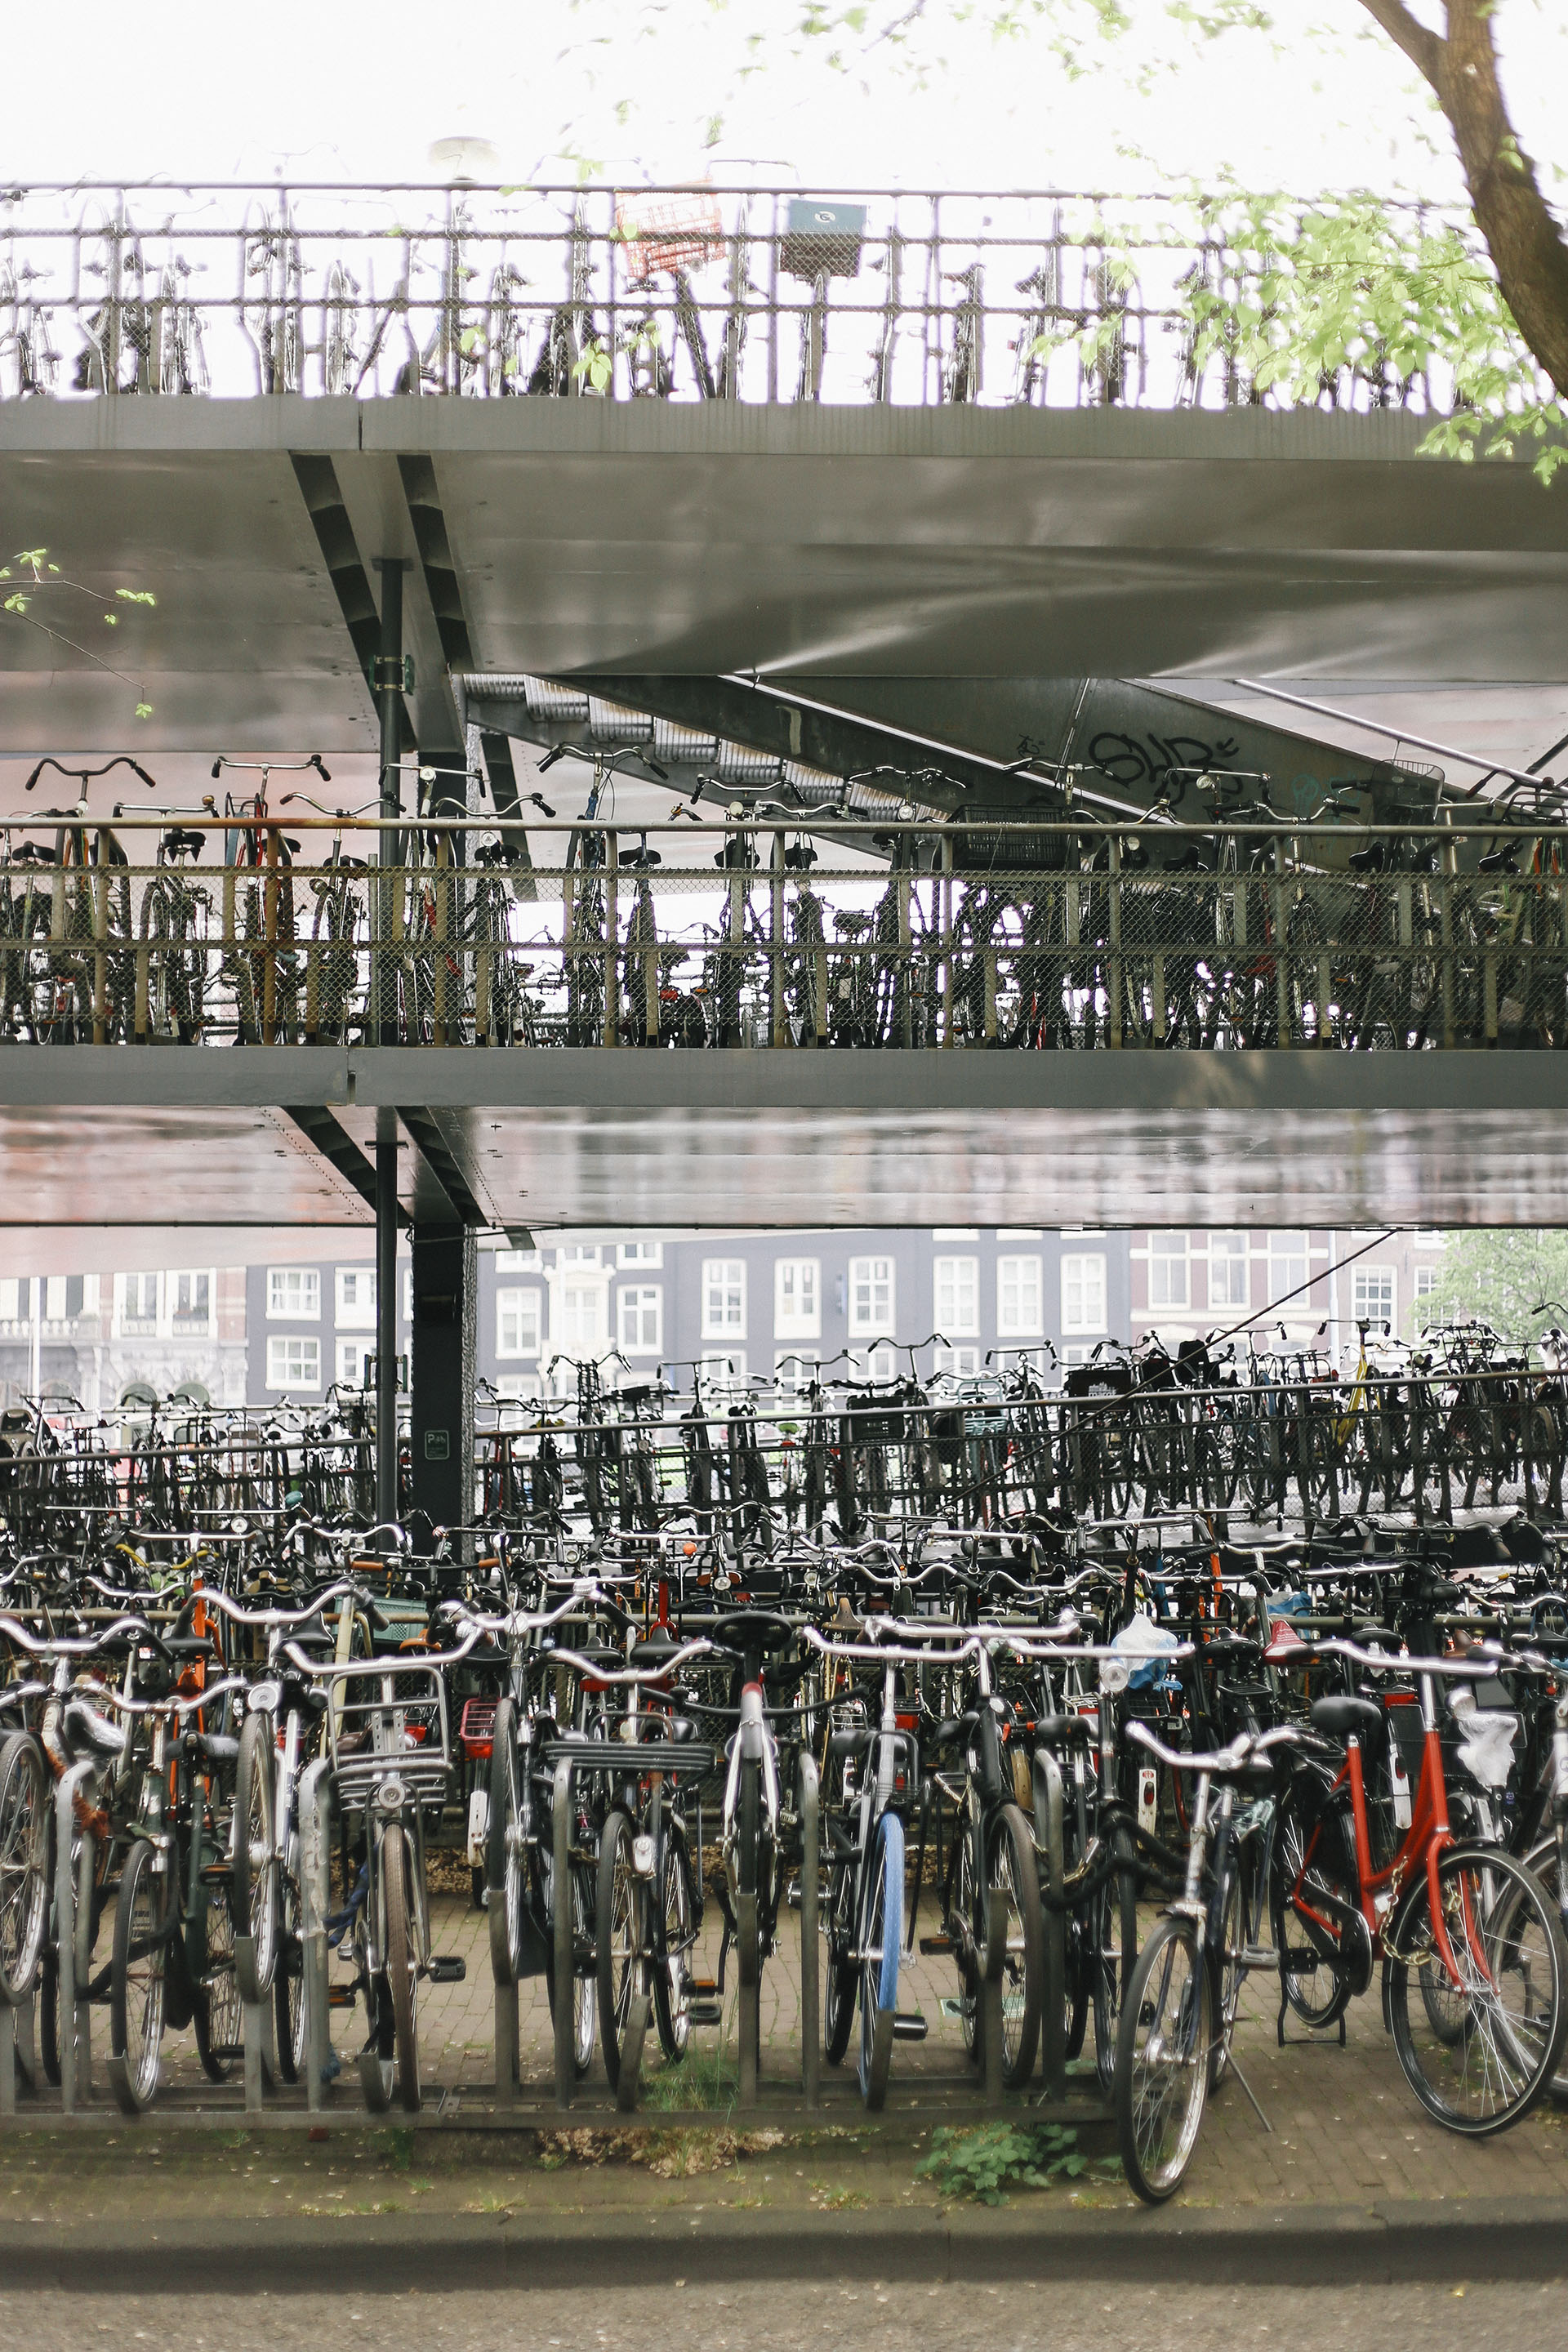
[5,0,1568,195]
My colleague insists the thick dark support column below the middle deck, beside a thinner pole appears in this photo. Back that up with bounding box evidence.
[409,1225,479,1526]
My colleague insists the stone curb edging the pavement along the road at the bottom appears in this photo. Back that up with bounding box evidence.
[0,2197,1568,2296]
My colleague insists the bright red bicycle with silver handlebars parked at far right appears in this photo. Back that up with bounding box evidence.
[1265,1625,1568,2138]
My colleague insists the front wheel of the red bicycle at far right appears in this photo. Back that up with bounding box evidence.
[1384,1846,1568,2138]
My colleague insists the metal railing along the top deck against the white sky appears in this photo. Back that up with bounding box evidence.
[0,184,1455,412]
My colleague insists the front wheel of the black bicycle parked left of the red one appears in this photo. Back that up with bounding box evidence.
[1116,1919,1213,2204]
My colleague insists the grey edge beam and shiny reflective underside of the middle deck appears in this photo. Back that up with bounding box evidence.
[0,1047,1568,1230]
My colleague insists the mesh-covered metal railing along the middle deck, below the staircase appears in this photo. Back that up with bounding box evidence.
[0,818,1568,1051]
